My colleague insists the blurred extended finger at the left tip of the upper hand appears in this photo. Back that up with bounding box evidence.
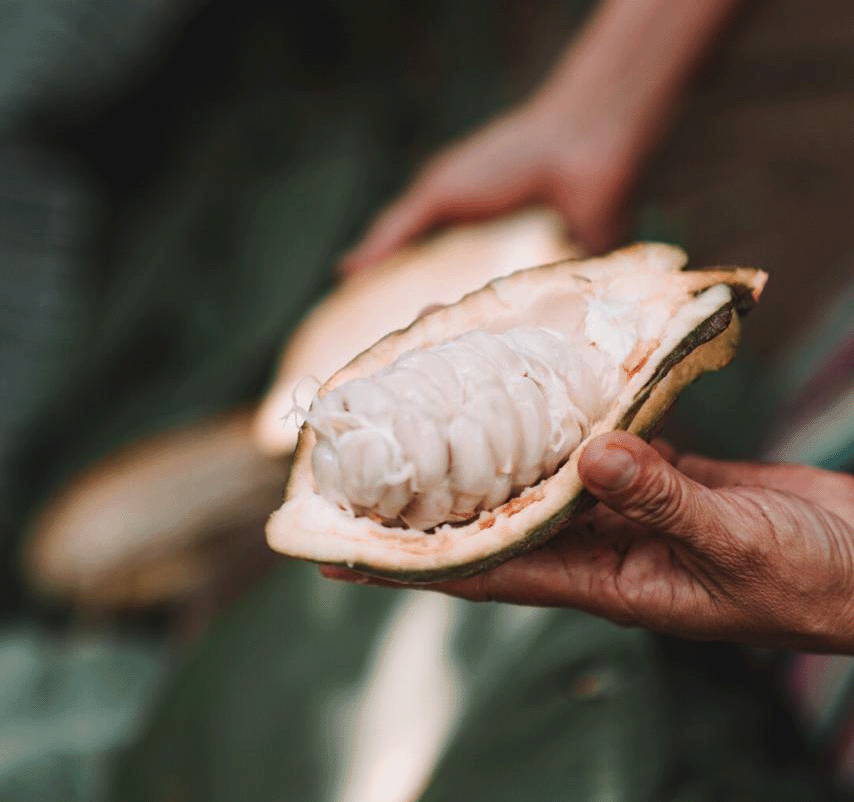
[341,184,441,274]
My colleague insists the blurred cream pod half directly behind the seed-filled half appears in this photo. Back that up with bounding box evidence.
[254,208,580,456]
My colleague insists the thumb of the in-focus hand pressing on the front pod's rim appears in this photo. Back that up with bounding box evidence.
[578,432,731,551]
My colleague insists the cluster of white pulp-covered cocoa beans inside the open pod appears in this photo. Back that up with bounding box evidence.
[307,327,622,530]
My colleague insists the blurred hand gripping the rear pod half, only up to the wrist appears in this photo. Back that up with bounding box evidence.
[341,105,636,273]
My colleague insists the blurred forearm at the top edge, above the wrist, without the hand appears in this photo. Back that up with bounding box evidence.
[532,0,739,153]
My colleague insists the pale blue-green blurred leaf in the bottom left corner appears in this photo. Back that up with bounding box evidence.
[0,625,162,802]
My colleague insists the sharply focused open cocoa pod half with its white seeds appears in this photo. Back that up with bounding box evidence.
[267,244,766,582]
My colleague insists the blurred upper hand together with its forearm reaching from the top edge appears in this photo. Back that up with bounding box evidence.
[341,0,737,273]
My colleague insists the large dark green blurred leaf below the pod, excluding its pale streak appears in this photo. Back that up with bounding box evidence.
[114,564,814,802]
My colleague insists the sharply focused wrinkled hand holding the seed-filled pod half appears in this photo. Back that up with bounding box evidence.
[323,432,854,653]
